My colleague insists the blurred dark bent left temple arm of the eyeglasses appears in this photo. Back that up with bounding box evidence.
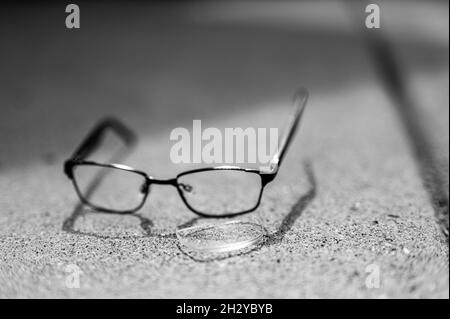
[71,117,137,160]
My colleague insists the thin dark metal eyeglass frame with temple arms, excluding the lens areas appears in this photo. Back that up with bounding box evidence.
[64,88,309,218]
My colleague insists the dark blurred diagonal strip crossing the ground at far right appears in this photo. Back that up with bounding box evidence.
[356,13,449,241]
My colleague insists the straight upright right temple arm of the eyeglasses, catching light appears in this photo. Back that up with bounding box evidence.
[270,88,309,174]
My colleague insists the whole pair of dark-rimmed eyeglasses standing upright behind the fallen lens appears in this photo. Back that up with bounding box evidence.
[64,88,308,218]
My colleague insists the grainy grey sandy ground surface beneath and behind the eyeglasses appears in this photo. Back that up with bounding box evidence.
[0,3,449,298]
